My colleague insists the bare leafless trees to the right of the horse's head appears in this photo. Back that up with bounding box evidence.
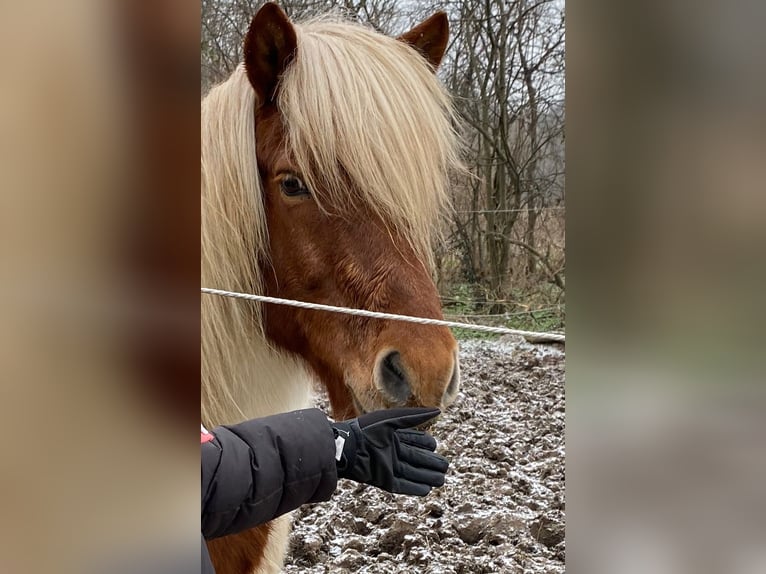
[436,0,564,312]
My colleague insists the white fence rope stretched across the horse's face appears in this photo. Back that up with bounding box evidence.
[202,287,564,343]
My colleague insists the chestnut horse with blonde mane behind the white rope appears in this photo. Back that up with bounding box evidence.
[201,3,461,574]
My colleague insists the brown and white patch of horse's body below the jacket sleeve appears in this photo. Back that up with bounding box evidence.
[207,515,290,574]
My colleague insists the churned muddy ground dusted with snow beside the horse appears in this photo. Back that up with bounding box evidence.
[284,340,565,574]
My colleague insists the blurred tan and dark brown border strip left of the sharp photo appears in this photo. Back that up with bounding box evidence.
[0,0,200,572]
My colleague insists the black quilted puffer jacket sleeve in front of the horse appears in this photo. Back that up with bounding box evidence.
[202,409,338,539]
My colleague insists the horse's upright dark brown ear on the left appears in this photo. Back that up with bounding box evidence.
[245,2,298,105]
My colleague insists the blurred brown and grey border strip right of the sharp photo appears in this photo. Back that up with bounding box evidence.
[566,0,766,573]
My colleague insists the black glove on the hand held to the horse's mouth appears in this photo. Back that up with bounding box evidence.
[332,408,449,496]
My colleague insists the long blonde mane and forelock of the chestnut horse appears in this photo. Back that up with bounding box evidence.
[202,14,460,424]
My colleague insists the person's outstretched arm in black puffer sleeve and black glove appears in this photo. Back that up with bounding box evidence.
[202,408,449,539]
